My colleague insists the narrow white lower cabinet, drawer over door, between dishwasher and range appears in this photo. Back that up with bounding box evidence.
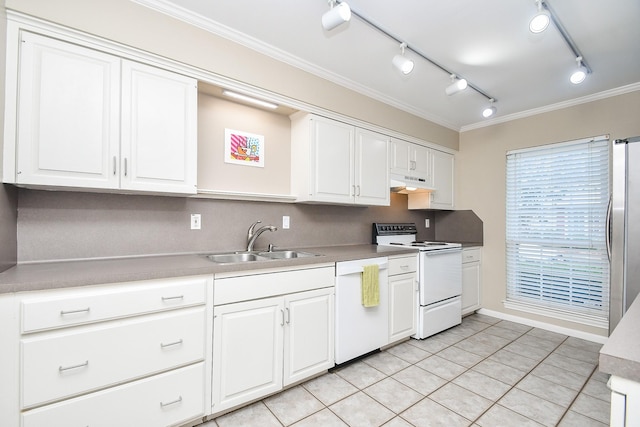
[389,255,418,343]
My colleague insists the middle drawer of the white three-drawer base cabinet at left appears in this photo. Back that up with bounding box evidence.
[21,307,205,408]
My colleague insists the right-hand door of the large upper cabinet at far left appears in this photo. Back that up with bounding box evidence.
[121,61,197,194]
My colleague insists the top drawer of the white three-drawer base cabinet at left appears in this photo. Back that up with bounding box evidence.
[22,276,209,333]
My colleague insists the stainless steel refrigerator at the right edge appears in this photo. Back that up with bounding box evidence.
[608,137,640,333]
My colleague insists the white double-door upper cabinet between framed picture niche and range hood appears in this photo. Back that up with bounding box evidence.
[291,114,389,206]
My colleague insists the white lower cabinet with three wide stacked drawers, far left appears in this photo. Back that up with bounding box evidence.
[0,276,213,427]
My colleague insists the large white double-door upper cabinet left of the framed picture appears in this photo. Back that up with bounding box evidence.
[4,31,197,194]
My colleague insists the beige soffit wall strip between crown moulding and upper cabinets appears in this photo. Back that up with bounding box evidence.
[6,0,459,149]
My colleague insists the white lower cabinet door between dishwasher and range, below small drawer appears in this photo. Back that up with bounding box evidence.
[389,273,418,343]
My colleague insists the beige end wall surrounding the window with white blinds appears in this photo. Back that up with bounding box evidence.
[456,91,640,335]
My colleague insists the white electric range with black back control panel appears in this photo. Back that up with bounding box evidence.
[373,223,462,339]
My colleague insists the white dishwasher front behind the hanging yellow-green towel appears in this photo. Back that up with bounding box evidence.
[335,257,389,364]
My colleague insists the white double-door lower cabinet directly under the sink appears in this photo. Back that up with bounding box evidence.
[212,268,335,414]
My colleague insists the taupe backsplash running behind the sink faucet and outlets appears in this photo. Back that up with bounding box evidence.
[17,189,482,262]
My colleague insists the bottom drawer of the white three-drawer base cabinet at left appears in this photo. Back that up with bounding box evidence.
[22,362,205,427]
